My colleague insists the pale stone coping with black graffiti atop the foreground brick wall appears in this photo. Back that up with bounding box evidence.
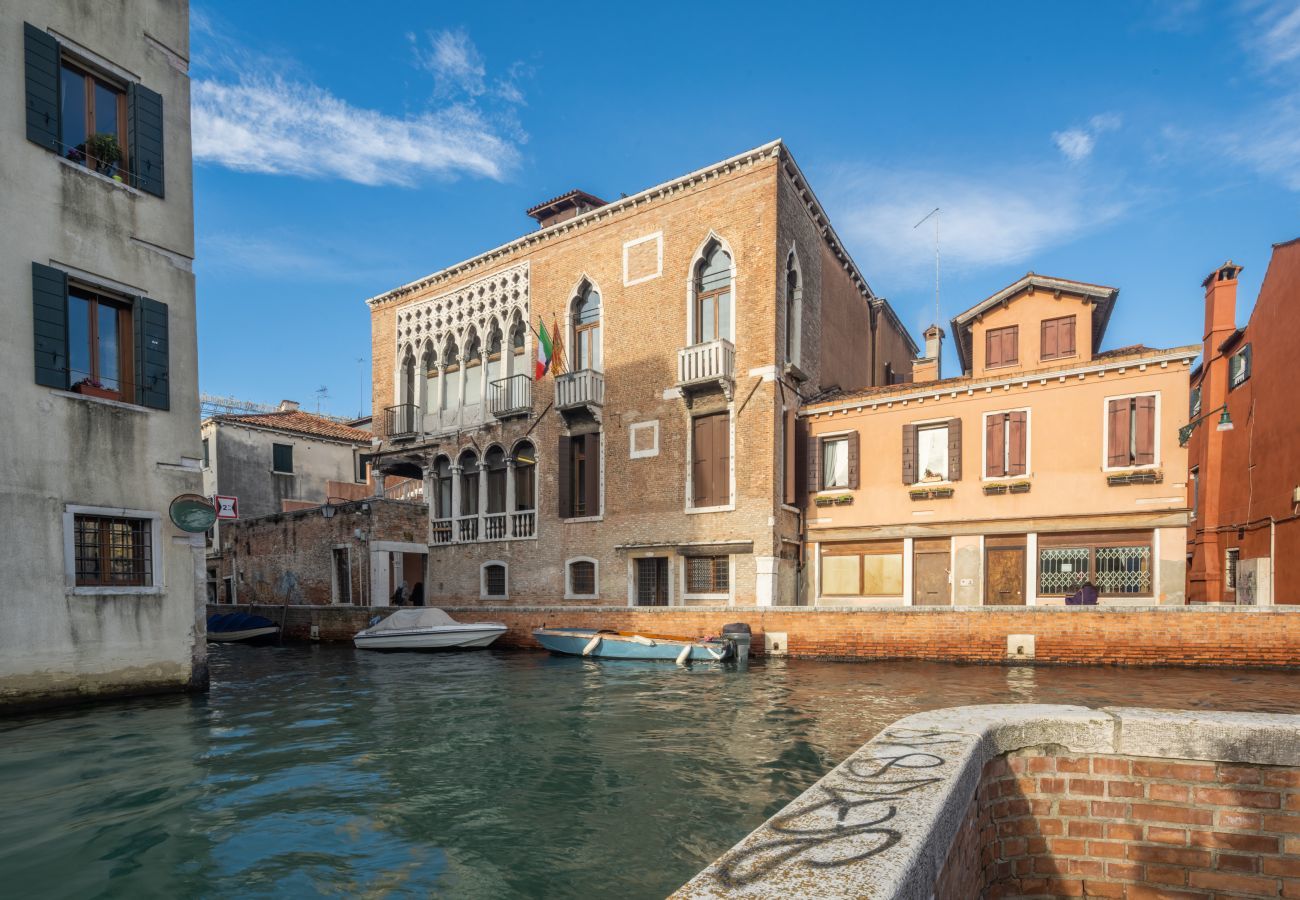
[673,704,1300,900]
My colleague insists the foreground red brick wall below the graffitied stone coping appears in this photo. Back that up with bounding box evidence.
[936,748,1300,900]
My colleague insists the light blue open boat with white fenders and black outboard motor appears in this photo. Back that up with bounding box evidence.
[533,624,750,666]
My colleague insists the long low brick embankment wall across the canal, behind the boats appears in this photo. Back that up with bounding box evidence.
[209,605,1300,667]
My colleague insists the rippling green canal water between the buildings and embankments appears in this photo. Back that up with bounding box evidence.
[0,645,1300,897]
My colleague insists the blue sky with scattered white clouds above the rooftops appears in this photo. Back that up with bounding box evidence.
[191,0,1300,415]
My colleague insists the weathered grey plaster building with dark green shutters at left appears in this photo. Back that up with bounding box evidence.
[0,0,207,705]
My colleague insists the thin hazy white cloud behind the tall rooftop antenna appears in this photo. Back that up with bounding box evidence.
[831,168,1126,284]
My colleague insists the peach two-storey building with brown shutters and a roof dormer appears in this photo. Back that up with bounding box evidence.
[800,273,1199,606]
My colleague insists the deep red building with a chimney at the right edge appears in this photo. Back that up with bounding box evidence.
[1183,238,1300,603]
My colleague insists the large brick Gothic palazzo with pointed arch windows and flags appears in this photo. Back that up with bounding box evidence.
[368,142,917,605]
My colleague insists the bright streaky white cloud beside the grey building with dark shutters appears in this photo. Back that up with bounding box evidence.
[192,77,517,186]
